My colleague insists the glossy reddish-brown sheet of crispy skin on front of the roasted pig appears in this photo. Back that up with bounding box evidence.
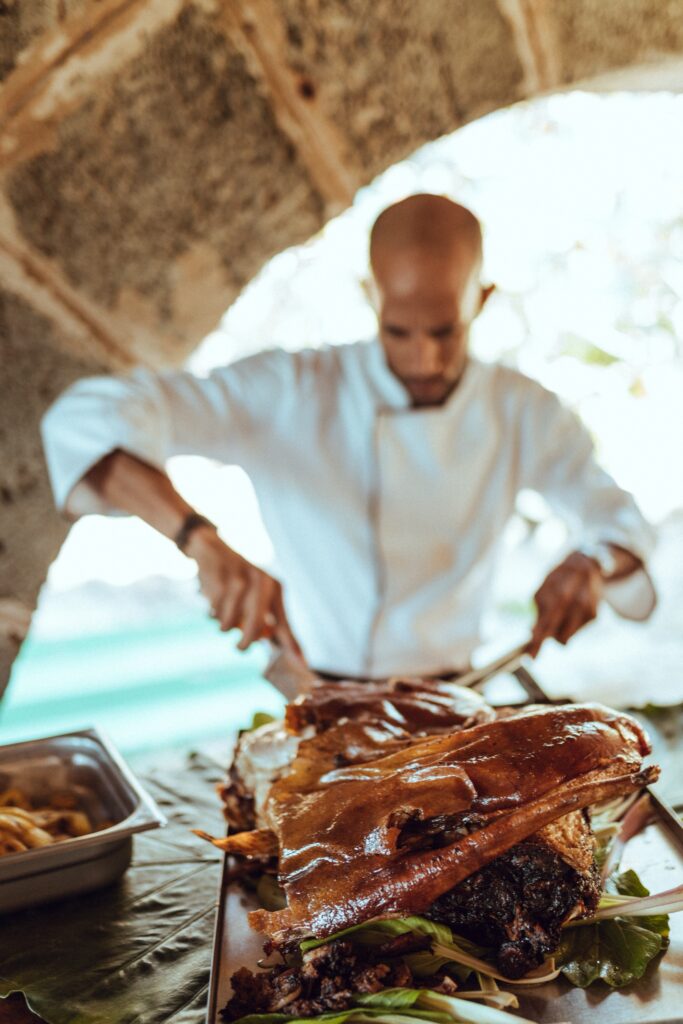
[251,705,657,937]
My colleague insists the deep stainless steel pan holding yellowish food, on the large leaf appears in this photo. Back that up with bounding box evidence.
[0,729,166,913]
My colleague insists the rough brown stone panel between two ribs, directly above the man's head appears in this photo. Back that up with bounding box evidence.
[281,0,523,181]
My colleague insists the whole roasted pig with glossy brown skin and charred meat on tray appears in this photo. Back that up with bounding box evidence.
[208,681,658,1013]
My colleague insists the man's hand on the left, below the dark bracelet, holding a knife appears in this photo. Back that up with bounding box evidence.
[184,527,301,655]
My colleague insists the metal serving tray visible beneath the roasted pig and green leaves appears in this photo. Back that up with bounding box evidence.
[207,679,683,1024]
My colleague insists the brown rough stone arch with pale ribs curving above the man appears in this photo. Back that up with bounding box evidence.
[0,0,683,682]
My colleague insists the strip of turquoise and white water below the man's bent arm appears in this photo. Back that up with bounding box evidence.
[0,616,284,754]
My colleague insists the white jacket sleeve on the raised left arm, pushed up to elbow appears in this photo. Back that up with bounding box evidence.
[42,351,291,510]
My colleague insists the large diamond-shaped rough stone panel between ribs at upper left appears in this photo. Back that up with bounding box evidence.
[6,7,324,365]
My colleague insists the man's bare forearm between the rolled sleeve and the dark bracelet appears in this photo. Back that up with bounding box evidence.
[77,450,194,538]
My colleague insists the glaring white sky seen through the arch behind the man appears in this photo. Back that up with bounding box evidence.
[49,93,683,591]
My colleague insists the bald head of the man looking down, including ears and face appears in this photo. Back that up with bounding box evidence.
[370,196,492,406]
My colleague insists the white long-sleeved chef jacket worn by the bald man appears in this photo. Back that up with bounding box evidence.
[43,340,652,677]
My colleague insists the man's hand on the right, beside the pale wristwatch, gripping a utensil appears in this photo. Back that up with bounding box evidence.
[528,551,603,657]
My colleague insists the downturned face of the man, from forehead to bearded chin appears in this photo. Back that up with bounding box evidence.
[375,244,487,407]
